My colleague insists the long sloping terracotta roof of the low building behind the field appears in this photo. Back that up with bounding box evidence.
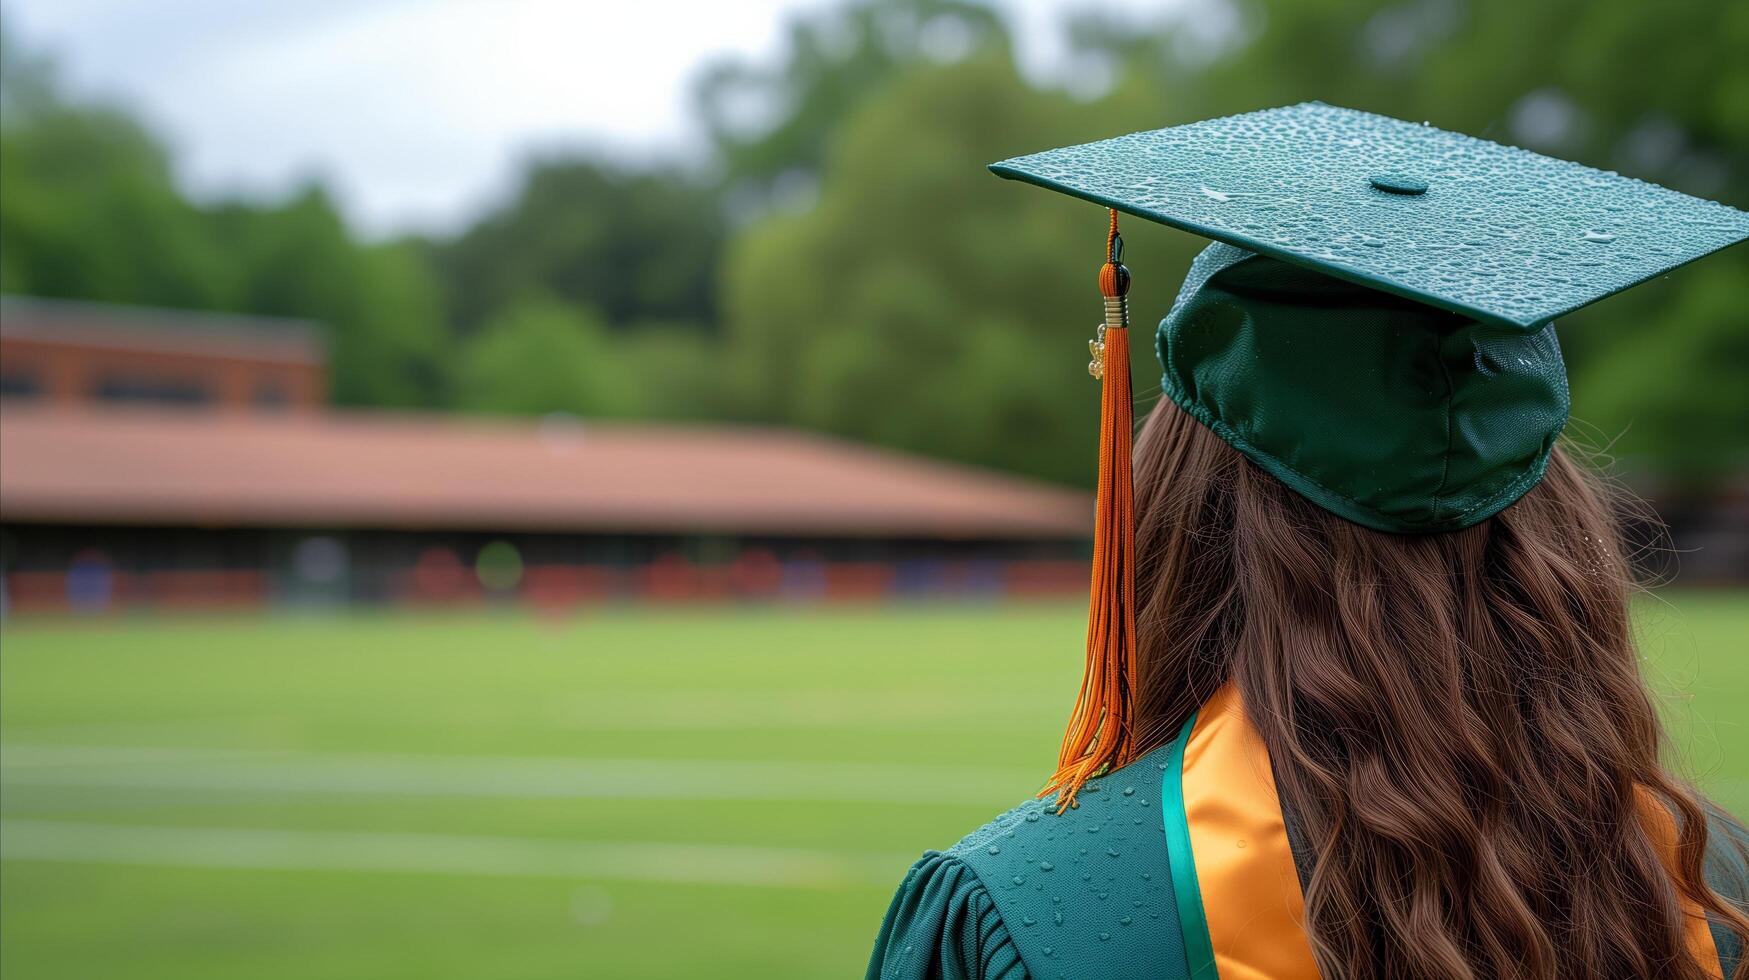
[0,404,1093,539]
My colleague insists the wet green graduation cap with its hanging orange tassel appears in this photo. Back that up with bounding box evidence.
[990,103,1749,805]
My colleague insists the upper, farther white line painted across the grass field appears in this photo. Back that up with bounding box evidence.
[0,746,1042,807]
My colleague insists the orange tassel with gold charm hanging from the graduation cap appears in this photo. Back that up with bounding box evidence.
[1039,212,1135,812]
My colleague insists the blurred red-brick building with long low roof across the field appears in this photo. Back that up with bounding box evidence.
[0,298,1091,613]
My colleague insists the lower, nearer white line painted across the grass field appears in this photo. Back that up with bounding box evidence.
[0,821,913,887]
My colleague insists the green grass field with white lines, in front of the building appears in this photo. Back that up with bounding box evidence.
[0,593,1749,980]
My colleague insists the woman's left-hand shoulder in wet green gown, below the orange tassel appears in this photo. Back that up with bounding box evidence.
[868,754,1182,980]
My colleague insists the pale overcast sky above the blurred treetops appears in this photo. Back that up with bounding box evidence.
[0,0,1174,235]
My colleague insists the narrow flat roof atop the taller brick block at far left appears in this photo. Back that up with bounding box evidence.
[0,296,327,364]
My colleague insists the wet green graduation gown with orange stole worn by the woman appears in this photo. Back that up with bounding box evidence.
[868,689,1749,980]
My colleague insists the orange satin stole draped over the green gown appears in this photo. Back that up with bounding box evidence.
[1168,684,1723,980]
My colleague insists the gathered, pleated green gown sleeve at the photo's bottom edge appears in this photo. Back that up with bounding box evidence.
[866,852,1028,980]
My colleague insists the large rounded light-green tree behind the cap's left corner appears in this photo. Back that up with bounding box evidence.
[726,51,1182,481]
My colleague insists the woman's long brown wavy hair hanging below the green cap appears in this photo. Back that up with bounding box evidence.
[1135,401,1749,980]
